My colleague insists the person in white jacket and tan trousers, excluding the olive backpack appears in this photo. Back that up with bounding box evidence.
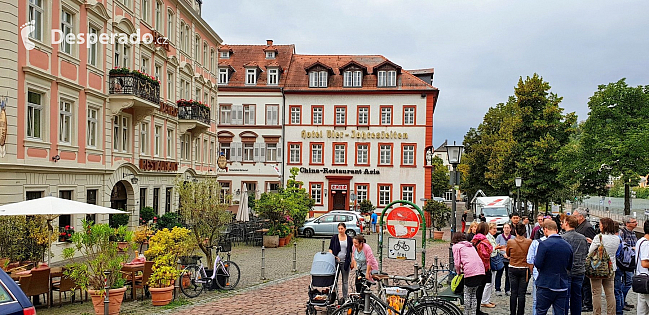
[588,218,620,315]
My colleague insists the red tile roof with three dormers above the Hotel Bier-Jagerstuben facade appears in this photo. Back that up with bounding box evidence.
[284,54,437,92]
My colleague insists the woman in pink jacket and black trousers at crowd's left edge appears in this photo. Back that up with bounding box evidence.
[452,233,485,315]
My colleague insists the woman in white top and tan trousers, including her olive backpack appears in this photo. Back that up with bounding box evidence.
[586,218,620,315]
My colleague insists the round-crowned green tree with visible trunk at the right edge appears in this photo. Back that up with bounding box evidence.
[580,79,649,215]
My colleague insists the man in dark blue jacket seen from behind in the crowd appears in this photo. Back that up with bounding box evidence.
[534,220,572,315]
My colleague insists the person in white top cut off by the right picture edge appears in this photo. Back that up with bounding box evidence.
[633,220,649,315]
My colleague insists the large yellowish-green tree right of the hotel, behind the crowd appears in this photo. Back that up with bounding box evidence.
[460,74,576,216]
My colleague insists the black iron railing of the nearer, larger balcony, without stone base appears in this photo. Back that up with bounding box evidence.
[108,74,160,105]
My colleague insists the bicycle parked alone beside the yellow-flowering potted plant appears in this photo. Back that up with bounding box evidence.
[180,246,241,298]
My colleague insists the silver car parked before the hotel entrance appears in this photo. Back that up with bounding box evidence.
[297,211,361,237]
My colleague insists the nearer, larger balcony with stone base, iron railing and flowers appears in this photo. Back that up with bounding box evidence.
[108,68,160,116]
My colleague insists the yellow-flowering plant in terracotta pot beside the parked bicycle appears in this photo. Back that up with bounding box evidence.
[144,227,196,306]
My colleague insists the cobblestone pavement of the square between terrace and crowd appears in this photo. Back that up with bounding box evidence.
[31,230,637,315]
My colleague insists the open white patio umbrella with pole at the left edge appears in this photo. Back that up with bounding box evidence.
[0,196,128,265]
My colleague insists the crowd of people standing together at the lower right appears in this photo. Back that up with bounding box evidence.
[452,209,649,315]
